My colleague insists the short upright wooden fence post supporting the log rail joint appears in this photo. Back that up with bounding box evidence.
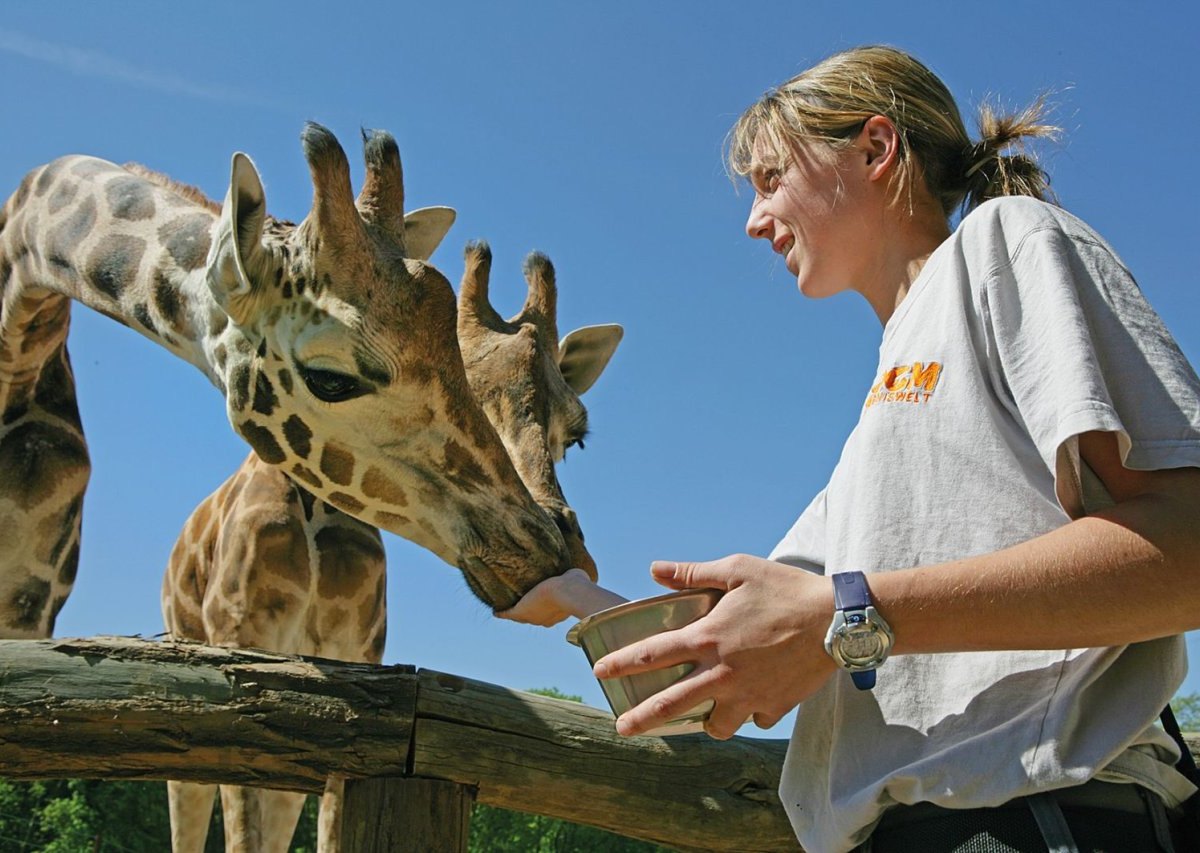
[341,776,475,853]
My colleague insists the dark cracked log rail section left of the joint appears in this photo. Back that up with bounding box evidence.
[0,637,416,793]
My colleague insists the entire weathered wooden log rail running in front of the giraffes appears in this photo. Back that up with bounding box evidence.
[0,637,799,852]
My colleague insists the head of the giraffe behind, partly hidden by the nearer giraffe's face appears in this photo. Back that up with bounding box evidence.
[458,244,623,579]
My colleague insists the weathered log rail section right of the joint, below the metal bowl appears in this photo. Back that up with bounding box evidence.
[412,671,799,852]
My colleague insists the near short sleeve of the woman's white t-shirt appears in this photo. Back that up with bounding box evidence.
[983,221,1200,517]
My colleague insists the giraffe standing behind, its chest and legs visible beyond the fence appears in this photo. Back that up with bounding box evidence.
[163,244,622,853]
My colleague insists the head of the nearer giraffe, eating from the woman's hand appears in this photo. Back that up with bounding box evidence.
[206,124,574,609]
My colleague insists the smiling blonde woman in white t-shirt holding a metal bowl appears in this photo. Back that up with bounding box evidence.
[595,47,1200,853]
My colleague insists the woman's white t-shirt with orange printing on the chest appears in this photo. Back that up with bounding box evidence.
[770,198,1200,853]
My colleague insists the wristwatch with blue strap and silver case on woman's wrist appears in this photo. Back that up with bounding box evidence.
[826,571,895,690]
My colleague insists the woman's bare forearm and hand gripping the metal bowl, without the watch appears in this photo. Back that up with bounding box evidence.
[595,432,1200,738]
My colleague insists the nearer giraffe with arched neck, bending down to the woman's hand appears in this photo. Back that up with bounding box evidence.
[0,122,585,638]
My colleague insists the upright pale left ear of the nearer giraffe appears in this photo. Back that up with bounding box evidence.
[208,151,266,325]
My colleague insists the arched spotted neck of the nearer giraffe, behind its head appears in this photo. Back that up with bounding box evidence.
[0,156,246,395]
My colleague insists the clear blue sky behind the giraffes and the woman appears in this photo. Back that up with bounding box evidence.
[0,0,1200,735]
